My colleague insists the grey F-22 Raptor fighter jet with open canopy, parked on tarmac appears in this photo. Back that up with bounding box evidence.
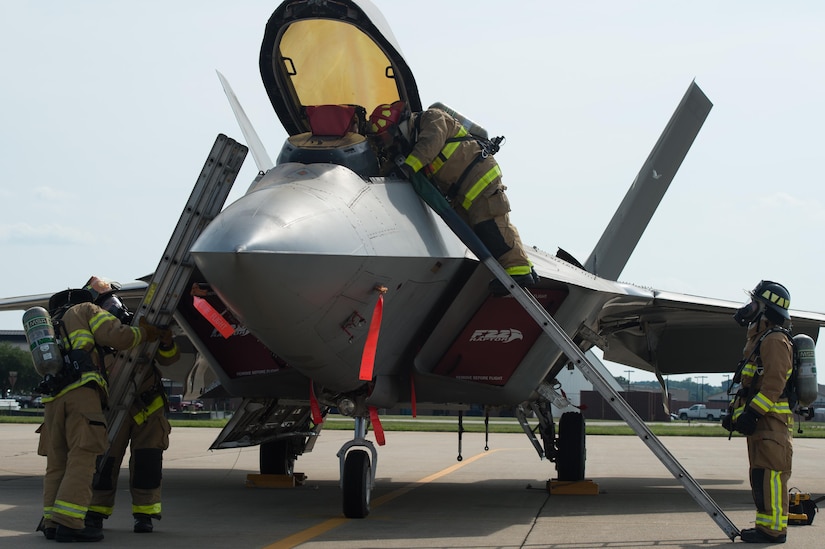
[0,0,825,518]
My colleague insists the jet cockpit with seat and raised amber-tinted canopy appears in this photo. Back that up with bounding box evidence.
[260,0,421,177]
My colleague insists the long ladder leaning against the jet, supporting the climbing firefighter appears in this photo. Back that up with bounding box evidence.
[411,173,739,540]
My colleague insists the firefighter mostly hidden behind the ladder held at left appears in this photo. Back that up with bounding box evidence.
[86,277,180,533]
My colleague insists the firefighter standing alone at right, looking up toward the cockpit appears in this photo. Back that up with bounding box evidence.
[726,280,793,543]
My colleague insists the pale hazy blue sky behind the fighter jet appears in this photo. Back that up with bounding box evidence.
[0,0,825,383]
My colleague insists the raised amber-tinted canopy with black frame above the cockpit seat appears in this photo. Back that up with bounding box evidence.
[260,0,421,135]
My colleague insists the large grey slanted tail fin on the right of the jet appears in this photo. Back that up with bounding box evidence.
[584,81,713,280]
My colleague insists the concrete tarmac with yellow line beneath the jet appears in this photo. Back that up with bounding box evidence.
[0,424,825,549]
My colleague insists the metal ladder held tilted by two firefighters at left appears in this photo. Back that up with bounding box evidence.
[100,134,248,458]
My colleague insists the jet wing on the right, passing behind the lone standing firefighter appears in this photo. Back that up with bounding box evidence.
[600,284,825,374]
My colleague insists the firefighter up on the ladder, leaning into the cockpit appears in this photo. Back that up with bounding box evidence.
[368,101,538,293]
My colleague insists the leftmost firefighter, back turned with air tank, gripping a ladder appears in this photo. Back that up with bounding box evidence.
[38,289,162,542]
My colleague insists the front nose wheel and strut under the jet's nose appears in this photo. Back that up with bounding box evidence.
[338,417,378,518]
